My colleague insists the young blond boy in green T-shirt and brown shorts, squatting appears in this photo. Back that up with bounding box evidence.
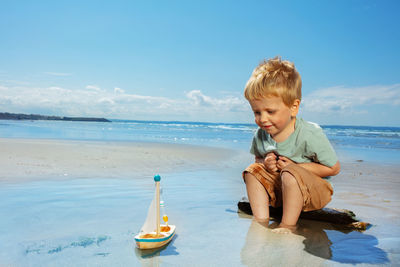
[243,57,340,233]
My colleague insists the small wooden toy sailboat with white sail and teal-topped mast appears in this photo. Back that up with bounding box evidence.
[135,175,175,249]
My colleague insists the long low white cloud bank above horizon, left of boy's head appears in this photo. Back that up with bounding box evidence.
[0,84,251,121]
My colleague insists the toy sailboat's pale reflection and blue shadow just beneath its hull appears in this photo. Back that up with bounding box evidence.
[135,237,179,266]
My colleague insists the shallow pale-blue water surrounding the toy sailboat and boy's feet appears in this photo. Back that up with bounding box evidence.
[0,171,400,266]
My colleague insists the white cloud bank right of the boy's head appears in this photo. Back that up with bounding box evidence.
[302,84,400,113]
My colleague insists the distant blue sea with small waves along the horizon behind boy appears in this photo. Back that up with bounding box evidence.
[0,120,400,164]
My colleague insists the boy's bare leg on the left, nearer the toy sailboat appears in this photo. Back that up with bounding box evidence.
[244,172,269,222]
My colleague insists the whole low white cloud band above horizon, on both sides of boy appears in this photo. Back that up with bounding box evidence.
[0,81,400,125]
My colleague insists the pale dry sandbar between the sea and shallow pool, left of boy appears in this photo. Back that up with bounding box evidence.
[0,138,249,182]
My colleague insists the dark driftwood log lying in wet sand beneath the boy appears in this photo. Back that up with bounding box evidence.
[238,198,370,230]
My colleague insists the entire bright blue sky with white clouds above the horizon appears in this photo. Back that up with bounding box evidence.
[0,0,400,126]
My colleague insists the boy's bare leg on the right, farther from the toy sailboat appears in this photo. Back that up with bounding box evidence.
[275,172,303,232]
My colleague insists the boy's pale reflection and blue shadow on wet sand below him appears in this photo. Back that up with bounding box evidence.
[241,220,389,266]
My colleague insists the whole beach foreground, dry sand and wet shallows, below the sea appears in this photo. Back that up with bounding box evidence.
[0,138,400,266]
